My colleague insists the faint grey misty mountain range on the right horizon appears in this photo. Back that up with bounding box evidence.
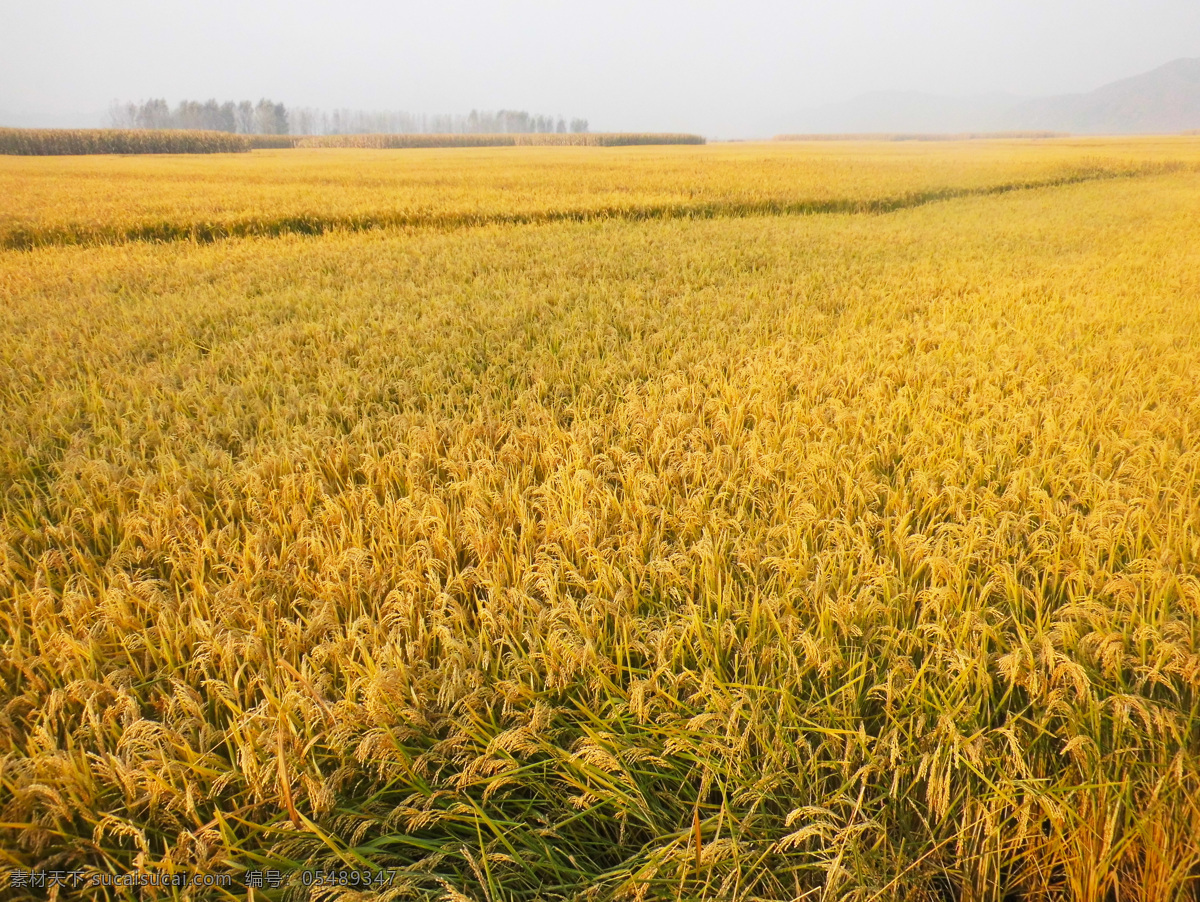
[790,59,1200,134]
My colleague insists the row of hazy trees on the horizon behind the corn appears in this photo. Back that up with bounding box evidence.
[109,97,588,134]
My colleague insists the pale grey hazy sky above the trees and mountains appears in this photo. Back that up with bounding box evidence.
[0,0,1200,137]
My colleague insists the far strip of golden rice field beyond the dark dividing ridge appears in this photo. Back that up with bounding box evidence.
[0,138,1200,249]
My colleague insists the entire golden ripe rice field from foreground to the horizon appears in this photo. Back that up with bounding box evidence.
[0,138,1200,902]
